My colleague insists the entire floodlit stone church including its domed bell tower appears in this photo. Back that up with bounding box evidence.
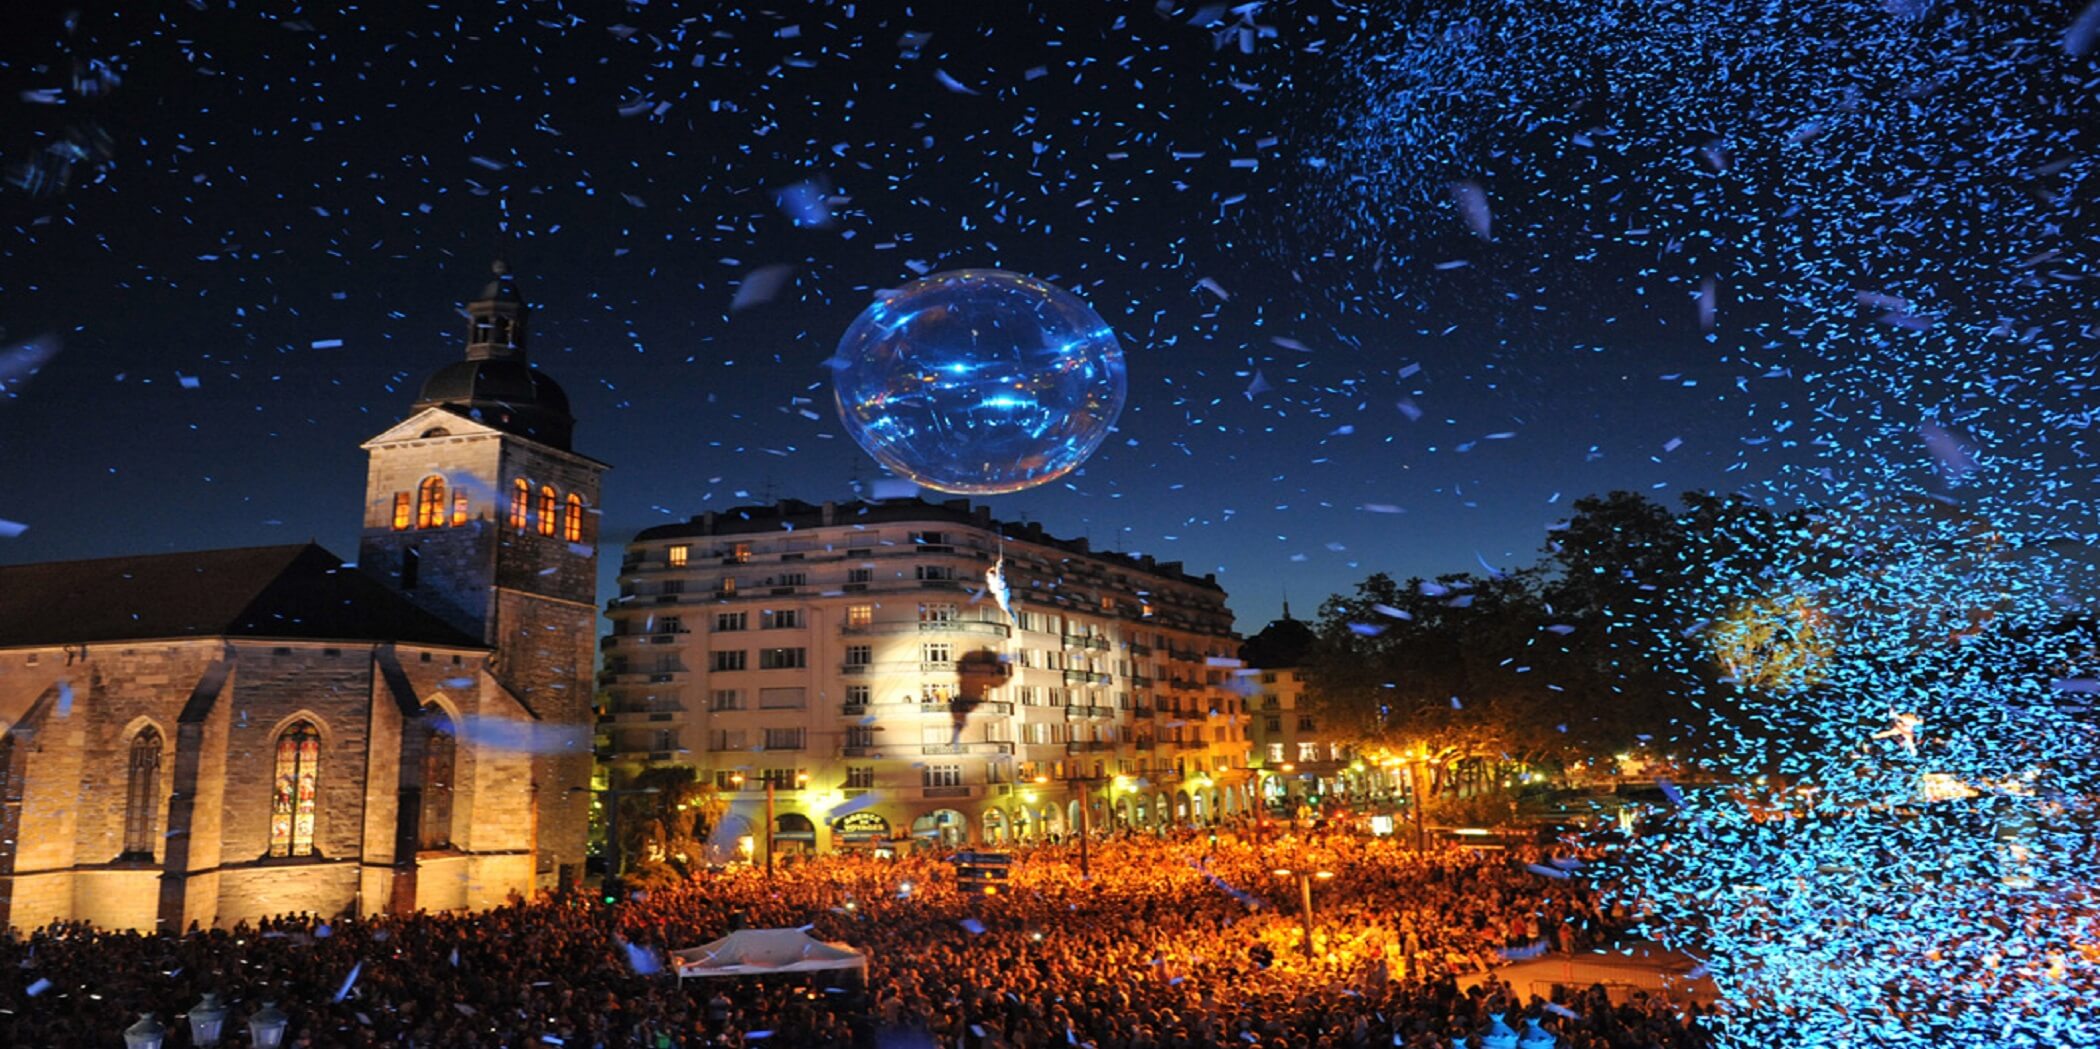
[0,262,605,929]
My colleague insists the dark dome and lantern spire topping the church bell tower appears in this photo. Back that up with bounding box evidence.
[414,258,575,451]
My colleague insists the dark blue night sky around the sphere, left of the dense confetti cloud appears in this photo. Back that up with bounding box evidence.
[0,0,1906,631]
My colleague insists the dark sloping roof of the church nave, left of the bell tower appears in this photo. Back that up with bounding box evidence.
[0,543,485,648]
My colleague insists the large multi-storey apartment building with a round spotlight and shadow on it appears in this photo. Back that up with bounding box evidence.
[601,499,1252,850]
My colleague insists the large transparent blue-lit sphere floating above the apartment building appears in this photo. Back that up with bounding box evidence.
[832,269,1128,495]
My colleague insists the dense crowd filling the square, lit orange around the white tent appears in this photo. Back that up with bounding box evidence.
[0,833,1709,1049]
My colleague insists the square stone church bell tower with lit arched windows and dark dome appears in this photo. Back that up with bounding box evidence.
[357,262,607,885]
